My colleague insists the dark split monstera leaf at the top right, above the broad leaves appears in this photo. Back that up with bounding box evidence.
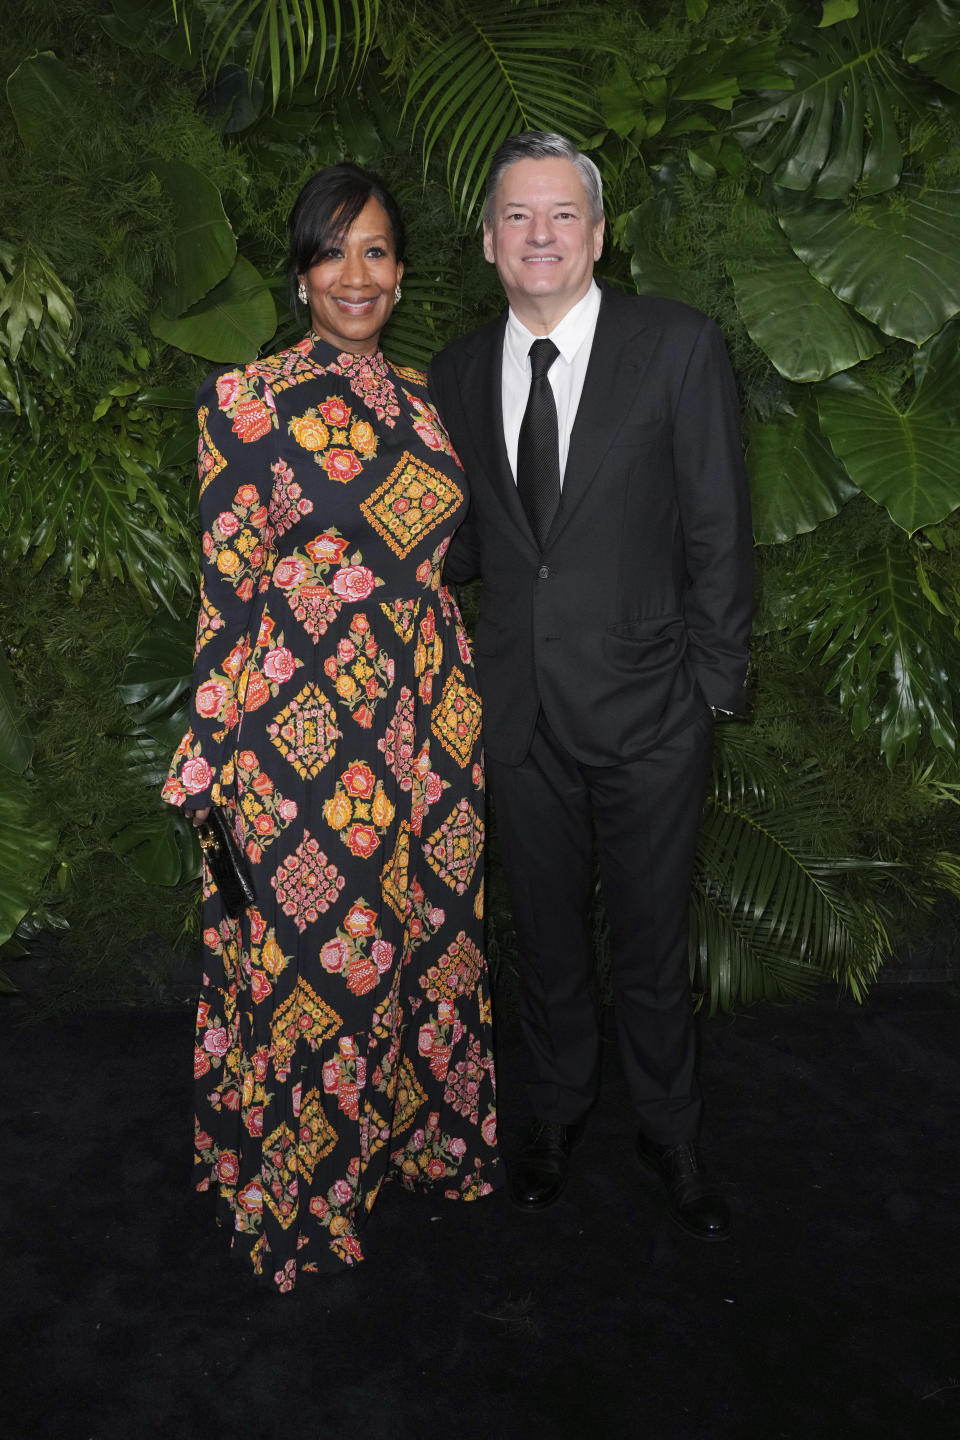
[733,0,915,199]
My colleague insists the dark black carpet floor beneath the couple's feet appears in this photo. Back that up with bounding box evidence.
[0,985,960,1440]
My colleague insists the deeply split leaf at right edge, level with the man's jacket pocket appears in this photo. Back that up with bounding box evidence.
[796,546,960,769]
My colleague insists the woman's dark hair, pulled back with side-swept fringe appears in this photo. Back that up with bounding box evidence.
[286,164,406,308]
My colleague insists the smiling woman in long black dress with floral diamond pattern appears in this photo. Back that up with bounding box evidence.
[164,164,499,1290]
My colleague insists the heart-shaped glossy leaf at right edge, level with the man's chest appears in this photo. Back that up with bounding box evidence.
[816,324,960,534]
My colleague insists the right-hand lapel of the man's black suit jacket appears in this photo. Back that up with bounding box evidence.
[546,291,659,543]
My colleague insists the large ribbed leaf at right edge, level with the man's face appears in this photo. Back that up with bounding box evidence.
[780,181,960,346]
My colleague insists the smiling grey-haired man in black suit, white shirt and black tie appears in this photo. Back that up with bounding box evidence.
[430,131,751,1240]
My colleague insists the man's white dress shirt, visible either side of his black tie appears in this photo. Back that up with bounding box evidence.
[501,281,600,485]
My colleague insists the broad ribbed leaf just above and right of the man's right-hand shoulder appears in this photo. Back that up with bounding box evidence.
[727,245,882,383]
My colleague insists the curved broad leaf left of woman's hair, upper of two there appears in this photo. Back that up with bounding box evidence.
[153,160,236,320]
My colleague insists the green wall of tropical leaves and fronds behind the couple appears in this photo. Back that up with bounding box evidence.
[0,0,960,1009]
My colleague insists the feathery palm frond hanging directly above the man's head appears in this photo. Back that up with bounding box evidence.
[406,0,599,216]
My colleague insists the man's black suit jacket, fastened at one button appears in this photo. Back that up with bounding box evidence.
[430,288,753,765]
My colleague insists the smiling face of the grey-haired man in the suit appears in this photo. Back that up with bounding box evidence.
[484,157,603,324]
